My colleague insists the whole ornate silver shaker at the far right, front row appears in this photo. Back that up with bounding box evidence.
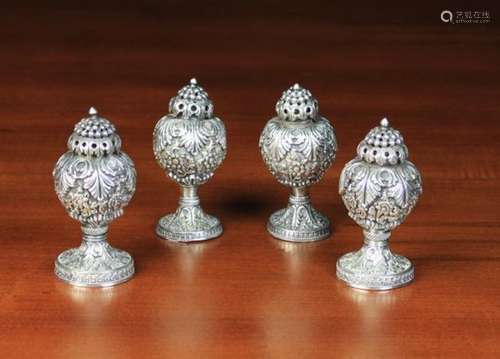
[337,118,422,290]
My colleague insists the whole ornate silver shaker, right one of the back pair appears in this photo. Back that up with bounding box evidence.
[259,84,337,242]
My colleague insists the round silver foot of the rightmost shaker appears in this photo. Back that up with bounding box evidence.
[337,251,415,290]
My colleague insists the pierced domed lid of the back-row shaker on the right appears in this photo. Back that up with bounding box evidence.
[276,84,319,122]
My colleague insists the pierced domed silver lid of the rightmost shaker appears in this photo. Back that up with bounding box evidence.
[357,118,408,166]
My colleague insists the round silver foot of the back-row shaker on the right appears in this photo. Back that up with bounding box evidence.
[267,207,330,242]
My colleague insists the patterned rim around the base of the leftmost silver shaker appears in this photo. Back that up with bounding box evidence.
[54,248,135,288]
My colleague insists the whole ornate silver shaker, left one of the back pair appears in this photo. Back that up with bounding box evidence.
[153,79,227,242]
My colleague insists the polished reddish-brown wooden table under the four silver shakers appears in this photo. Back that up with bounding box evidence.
[0,6,500,358]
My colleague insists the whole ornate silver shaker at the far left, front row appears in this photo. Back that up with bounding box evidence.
[53,108,136,287]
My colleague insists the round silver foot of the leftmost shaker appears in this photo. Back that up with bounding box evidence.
[54,242,134,287]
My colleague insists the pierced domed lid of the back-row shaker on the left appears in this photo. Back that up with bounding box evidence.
[169,78,214,119]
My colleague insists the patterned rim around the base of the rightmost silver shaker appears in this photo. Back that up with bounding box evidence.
[337,253,415,290]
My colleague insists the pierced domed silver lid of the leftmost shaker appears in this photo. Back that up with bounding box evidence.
[68,107,121,156]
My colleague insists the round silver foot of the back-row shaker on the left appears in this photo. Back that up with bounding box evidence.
[156,213,222,242]
